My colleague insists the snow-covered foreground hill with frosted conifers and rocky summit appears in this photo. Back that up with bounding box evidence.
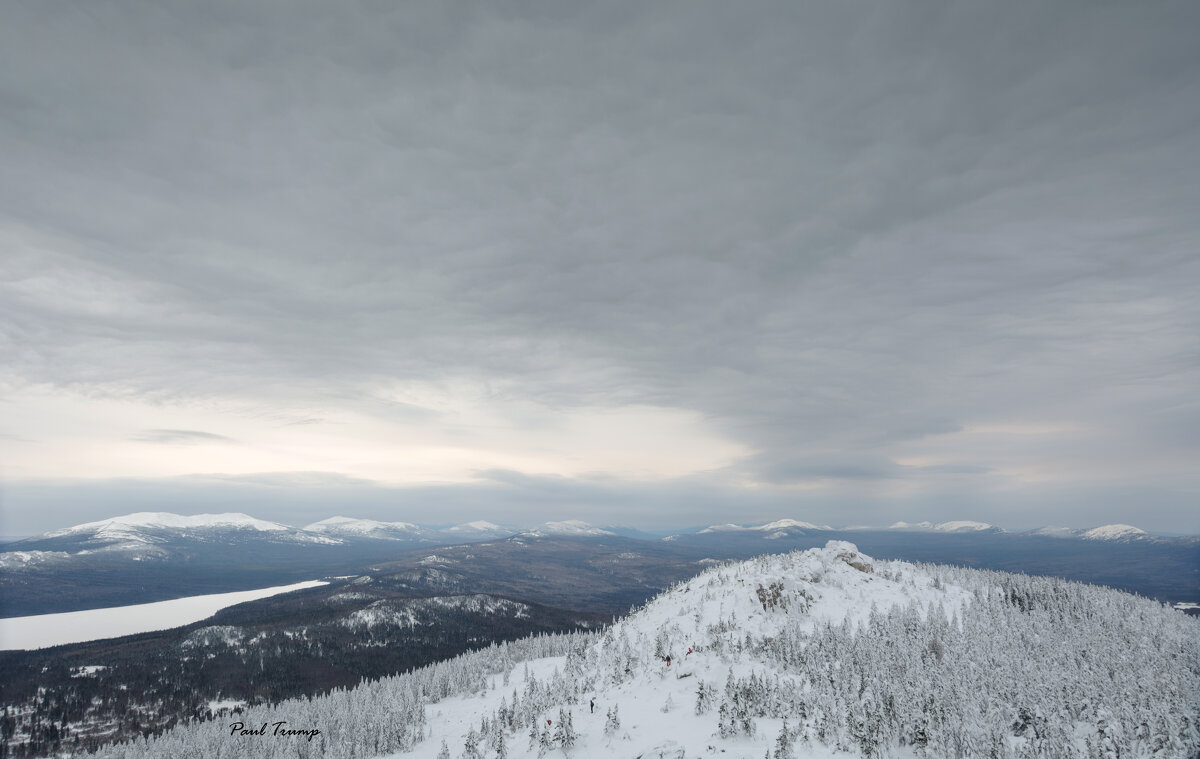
[100,542,1200,759]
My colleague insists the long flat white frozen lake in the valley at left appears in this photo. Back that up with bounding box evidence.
[0,580,328,651]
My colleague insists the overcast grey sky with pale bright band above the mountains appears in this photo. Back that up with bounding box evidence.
[0,0,1200,534]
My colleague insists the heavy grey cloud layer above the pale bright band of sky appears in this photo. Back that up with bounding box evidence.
[0,1,1200,530]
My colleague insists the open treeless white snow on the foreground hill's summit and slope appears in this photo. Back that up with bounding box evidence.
[390,540,972,759]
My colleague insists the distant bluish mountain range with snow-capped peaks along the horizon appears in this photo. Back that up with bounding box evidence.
[0,512,1200,616]
